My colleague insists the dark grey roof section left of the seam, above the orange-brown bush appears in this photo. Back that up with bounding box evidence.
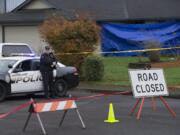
[10,0,127,20]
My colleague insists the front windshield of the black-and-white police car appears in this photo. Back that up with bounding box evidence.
[0,60,17,73]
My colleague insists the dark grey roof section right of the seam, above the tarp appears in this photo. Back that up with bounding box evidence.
[126,0,180,19]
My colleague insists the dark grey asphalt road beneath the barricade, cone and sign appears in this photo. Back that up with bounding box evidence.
[0,92,180,135]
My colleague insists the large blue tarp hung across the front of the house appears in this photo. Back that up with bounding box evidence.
[101,21,180,56]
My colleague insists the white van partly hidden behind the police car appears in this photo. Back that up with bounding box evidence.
[0,43,35,58]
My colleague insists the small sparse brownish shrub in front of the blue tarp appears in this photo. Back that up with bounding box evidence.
[145,41,161,62]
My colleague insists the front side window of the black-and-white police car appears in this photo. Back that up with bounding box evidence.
[14,60,31,72]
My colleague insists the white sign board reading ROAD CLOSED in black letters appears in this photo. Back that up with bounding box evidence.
[129,69,169,98]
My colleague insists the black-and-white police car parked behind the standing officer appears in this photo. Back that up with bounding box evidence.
[0,56,79,101]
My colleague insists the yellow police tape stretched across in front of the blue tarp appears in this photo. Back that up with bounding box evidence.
[55,46,180,56]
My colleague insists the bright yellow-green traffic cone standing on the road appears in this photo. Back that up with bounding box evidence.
[104,103,119,123]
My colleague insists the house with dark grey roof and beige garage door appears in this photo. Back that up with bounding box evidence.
[0,0,180,52]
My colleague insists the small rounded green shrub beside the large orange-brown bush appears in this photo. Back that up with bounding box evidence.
[82,56,104,81]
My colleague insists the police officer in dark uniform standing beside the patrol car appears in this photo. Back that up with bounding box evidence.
[40,46,56,98]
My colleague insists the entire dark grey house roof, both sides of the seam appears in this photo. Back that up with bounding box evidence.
[15,0,180,19]
